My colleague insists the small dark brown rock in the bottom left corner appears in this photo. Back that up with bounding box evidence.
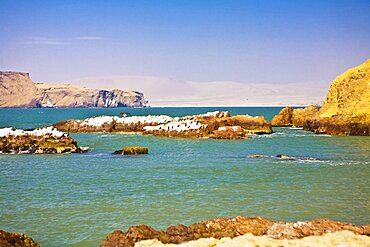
[0,230,41,247]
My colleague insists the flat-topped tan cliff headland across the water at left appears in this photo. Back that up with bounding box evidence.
[0,71,147,108]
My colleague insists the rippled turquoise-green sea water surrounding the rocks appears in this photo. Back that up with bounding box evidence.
[0,108,370,246]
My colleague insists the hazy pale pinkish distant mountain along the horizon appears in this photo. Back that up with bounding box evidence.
[72,76,330,106]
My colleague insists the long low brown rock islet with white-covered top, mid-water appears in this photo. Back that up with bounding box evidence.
[53,111,272,139]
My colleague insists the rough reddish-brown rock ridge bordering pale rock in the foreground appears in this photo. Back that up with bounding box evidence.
[101,216,370,247]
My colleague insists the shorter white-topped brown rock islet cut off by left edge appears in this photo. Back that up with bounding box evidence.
[0,127,86,154]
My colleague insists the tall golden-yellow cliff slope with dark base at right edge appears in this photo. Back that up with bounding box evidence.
[304,60,370,136]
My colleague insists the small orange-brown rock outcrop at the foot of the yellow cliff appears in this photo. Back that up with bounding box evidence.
[271,105,319,127]
